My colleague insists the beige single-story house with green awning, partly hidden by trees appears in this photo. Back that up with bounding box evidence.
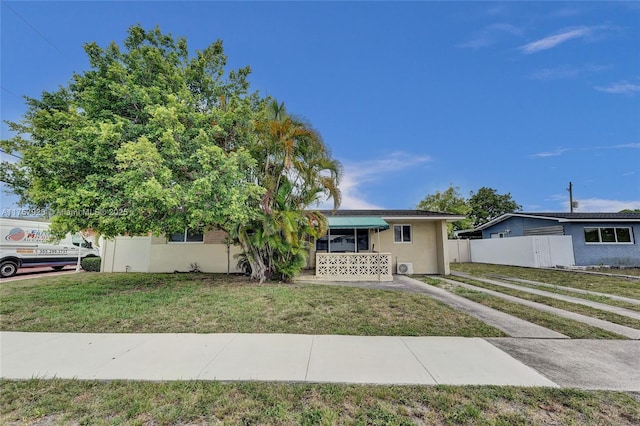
[101,210,463,279]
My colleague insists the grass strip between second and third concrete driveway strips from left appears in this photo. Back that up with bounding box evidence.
[451,276,640,329]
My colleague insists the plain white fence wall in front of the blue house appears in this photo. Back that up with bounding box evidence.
[470,235,575,268]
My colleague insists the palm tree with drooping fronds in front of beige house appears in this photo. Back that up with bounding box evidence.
[234,100,342,282]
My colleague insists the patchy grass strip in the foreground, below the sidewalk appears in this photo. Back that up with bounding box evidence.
[0,379,640,425]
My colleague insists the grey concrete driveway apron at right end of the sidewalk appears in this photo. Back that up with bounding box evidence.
[486,338,640,392]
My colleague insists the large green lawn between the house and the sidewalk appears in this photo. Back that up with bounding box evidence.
[0,273,504,337]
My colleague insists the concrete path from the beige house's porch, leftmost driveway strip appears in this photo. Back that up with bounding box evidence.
[298,275,568,339]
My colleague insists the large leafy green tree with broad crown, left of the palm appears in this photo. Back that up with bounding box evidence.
[1,26,264,237]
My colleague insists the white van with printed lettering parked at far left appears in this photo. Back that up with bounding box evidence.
[0,218,100,278]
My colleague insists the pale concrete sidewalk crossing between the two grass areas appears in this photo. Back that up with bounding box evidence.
[0,332,558,387]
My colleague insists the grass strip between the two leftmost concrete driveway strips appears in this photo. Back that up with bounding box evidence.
[425,278,626,339]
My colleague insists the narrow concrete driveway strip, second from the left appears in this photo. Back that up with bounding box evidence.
[440,278,640,340]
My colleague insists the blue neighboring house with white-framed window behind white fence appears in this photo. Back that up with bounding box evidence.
[475,213,640,266]
